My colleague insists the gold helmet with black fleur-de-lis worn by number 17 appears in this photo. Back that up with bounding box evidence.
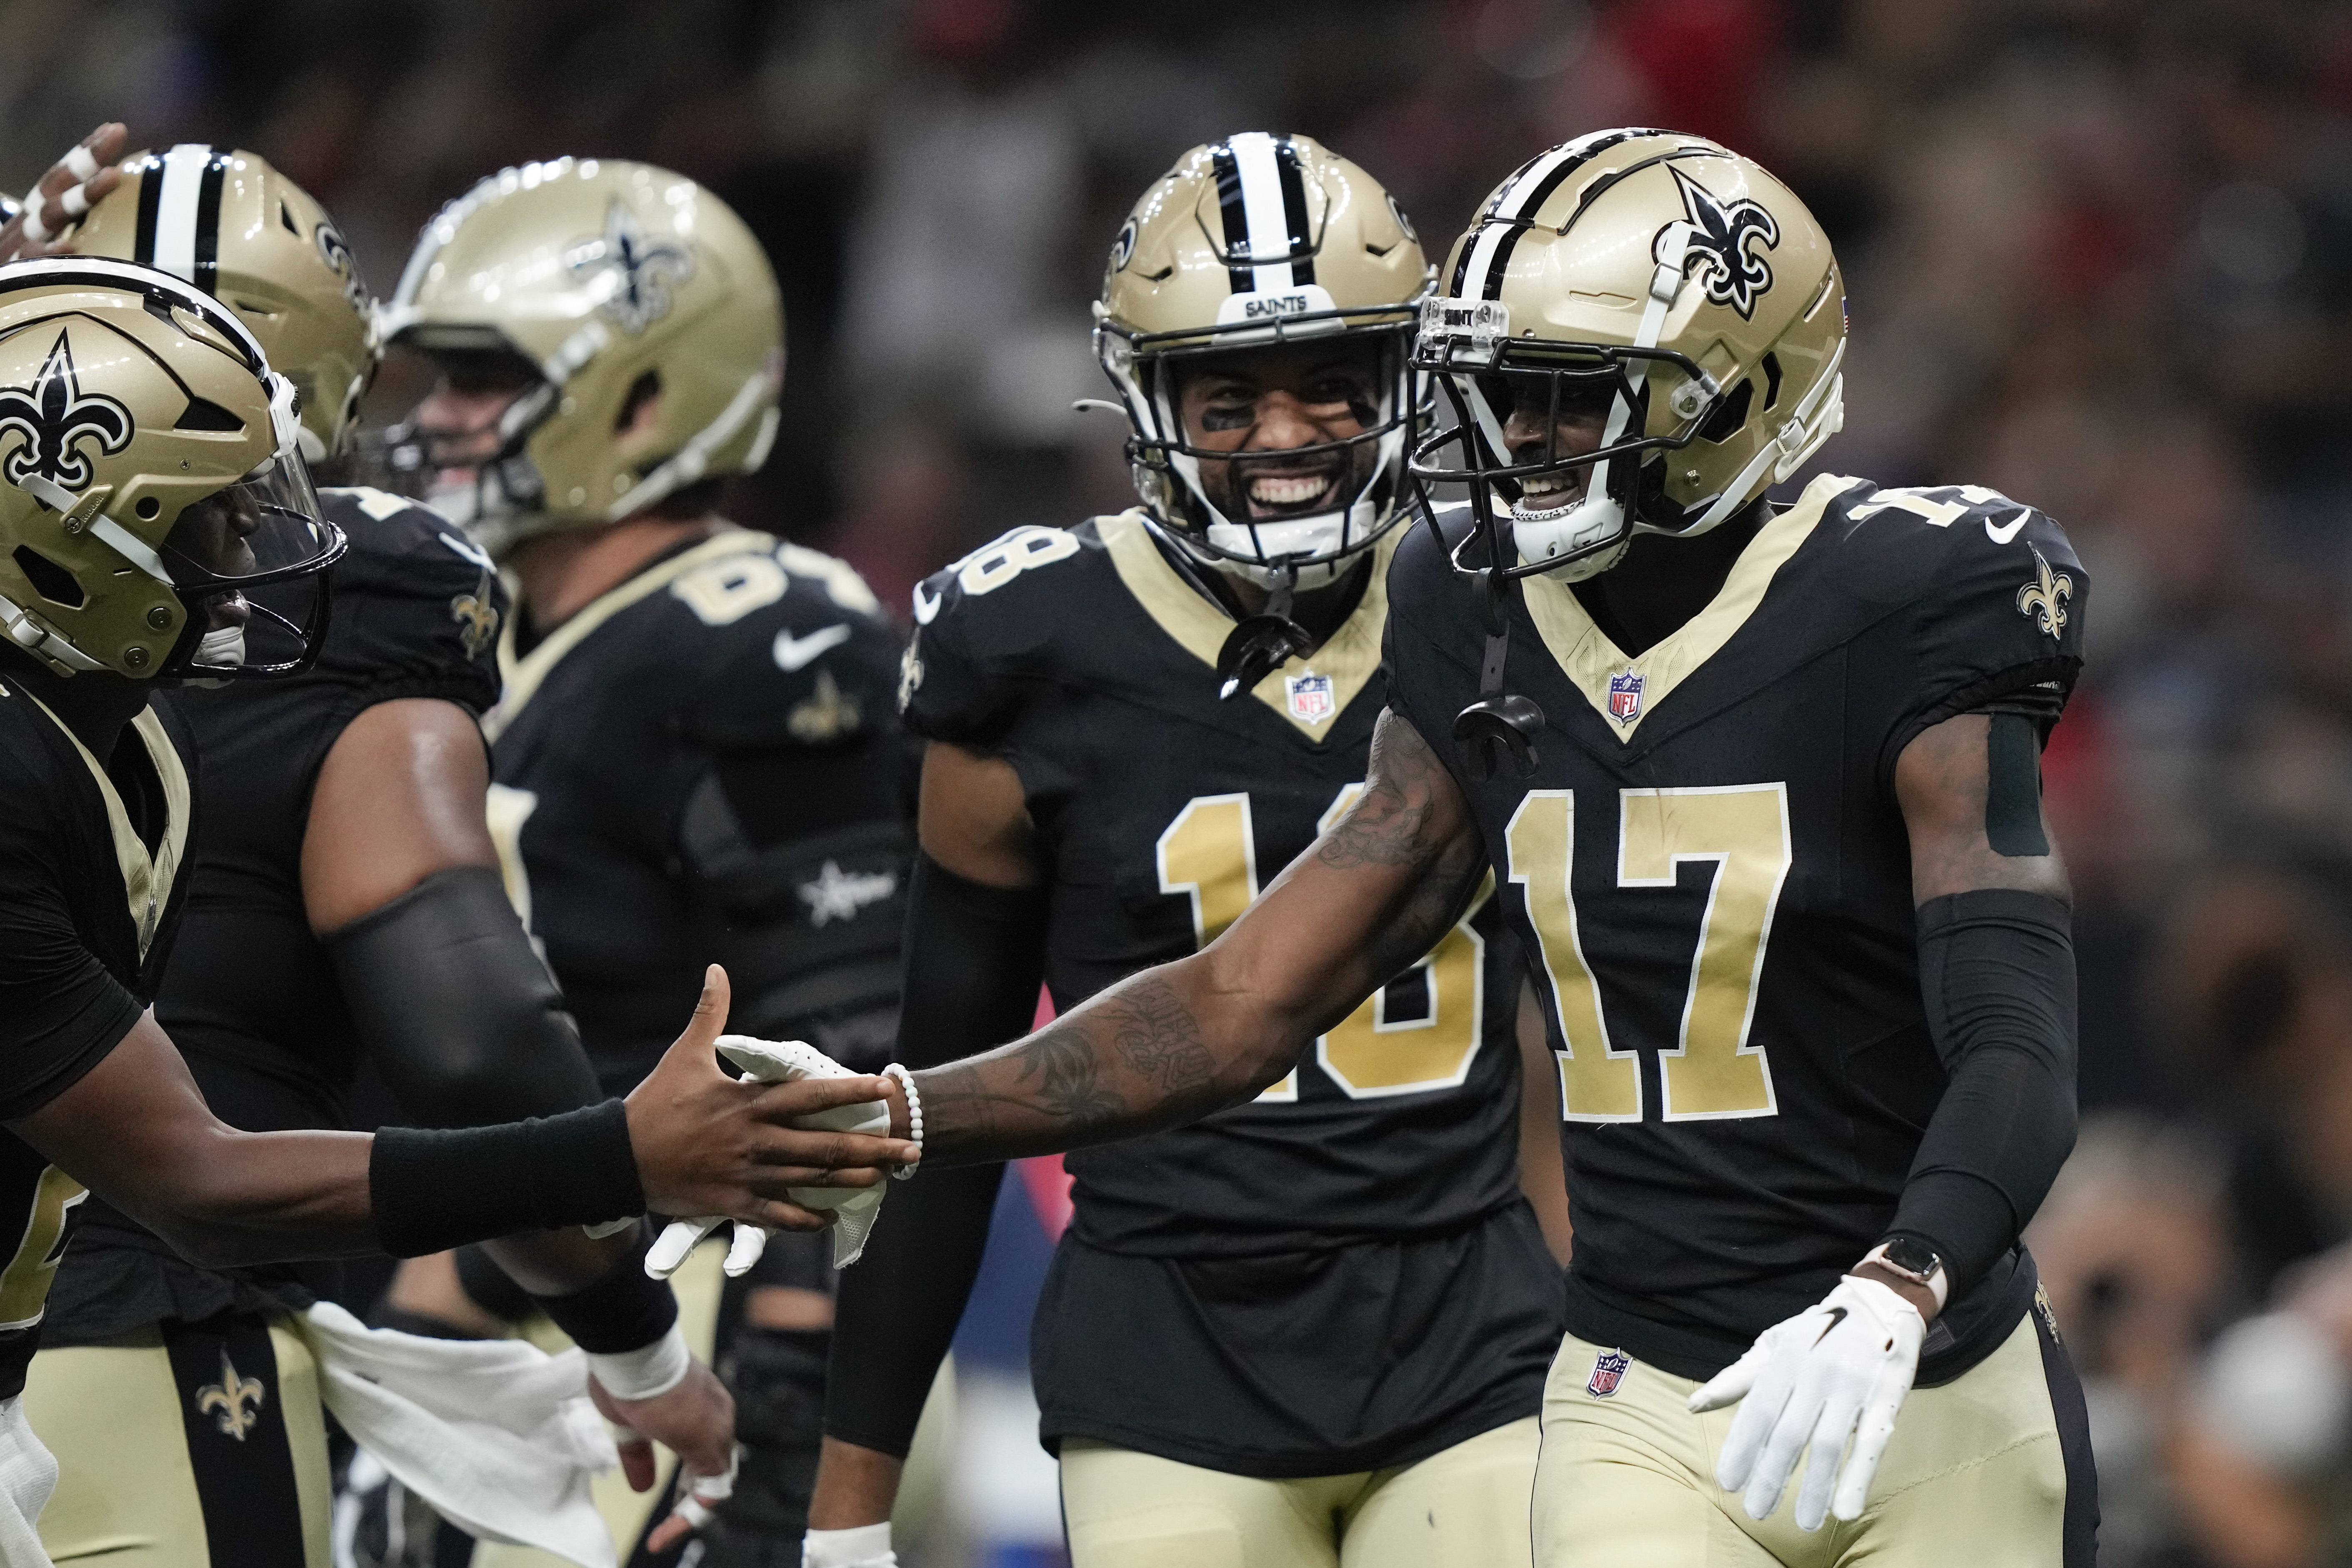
[1413,129,1846,581]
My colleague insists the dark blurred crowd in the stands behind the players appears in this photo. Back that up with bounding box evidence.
[0,0,2352,1568]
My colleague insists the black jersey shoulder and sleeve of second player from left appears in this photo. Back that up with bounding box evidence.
[318,489,511,712]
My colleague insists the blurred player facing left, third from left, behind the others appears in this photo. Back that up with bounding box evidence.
[383,160,910,1563]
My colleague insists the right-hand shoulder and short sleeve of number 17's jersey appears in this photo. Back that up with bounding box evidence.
[1825,484,2091,712]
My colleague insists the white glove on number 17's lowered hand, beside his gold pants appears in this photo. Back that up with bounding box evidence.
[1689,1274,1926,1530]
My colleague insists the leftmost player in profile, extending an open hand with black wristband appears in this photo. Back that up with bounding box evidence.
[0,256,910,1568]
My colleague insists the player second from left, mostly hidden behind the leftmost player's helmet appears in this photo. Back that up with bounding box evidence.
[11,146,734,1563]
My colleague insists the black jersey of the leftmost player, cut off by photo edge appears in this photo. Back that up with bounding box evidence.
[0,675,195,1399]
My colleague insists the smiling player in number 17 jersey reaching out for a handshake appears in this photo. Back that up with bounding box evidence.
[828,129,2098,1565]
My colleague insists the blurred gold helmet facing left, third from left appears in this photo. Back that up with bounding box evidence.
[383,158,783,555]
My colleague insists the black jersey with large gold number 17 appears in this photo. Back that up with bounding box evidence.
[1388,477,2089,1382]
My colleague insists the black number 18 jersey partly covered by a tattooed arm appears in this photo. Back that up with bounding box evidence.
[903,513,1519,1257]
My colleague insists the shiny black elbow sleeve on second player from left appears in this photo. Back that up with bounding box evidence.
[327,865,602,1126]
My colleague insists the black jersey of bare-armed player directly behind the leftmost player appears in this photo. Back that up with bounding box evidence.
[47,489,506,1345]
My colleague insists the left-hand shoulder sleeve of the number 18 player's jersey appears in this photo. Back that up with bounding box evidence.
[899,519,1100,745]
